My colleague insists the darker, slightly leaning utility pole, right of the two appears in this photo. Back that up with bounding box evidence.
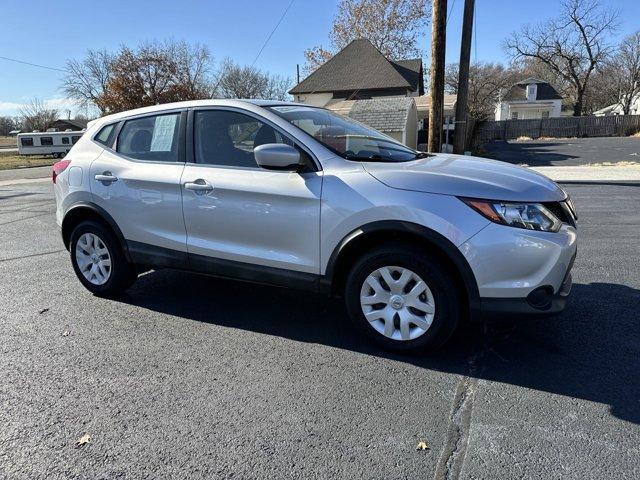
[453,0,475,153]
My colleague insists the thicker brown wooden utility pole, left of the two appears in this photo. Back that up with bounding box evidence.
[427,0,447,152]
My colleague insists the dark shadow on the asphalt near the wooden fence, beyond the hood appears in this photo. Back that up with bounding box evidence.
[484,140,581,167]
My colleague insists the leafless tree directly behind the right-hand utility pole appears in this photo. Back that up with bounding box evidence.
[445,63,521,120]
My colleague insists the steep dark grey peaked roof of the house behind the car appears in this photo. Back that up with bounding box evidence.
[289,39,422,95]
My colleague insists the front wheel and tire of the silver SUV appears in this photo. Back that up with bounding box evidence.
[345,244,461,351]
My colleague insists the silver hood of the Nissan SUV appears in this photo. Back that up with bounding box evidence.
[363,154,566,202]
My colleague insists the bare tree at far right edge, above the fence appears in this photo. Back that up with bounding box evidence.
[607,31,640,115]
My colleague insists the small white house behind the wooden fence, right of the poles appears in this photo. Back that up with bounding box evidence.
[495,78,562,120]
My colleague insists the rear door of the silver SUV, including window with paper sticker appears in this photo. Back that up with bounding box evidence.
[90,111,186,266]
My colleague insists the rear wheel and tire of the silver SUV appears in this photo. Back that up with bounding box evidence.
[69,220,138,296]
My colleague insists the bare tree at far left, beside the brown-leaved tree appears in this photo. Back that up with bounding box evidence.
[62,50,115,114]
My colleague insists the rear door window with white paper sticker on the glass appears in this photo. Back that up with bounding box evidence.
[117,113,180,162]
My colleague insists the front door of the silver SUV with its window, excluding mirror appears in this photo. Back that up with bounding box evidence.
[182,109,322,279]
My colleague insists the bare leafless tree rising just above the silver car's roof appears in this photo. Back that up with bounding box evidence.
[214,59,291,100]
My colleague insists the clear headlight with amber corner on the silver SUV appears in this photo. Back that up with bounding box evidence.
[460,198,562,232]
